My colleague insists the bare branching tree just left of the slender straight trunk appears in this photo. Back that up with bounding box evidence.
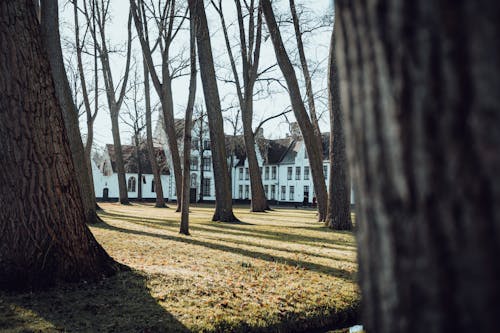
[130,0,187,212]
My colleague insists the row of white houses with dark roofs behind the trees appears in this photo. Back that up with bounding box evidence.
[93,120,354,204]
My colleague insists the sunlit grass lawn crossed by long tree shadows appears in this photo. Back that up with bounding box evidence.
[0,203,360,332]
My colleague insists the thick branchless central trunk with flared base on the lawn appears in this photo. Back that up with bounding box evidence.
[189,0,238,222]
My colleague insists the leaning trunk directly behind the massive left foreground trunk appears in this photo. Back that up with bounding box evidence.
[40,0,101,224]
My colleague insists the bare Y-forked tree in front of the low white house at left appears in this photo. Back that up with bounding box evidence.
[81,0,132,205]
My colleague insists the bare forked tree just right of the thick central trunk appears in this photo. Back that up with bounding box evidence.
[211,0,269,212]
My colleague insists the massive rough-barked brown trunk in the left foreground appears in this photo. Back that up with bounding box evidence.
[0,0,117,289]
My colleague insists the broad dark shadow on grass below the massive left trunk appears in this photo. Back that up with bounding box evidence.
[0,271,190,332]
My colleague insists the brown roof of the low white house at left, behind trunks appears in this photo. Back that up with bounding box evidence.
[106,144,170,175]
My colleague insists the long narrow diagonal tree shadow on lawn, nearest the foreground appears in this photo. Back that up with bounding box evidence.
[95,223,355,281]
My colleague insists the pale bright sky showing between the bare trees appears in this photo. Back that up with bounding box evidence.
[60,0,332,147]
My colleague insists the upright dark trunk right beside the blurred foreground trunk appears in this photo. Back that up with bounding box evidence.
[326,26,352,230]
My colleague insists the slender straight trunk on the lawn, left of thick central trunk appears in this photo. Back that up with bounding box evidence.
[179,13,196,235]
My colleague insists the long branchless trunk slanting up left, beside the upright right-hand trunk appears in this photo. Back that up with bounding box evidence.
[262,0,328,221]
